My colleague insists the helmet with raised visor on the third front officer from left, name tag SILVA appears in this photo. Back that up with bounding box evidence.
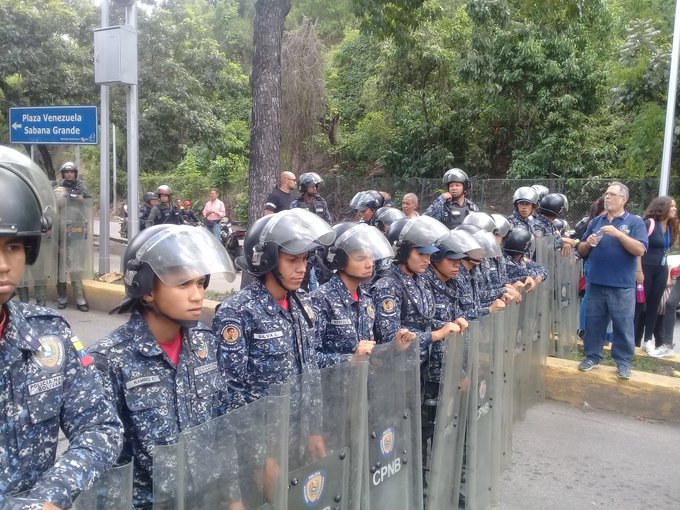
[236,209,335,276]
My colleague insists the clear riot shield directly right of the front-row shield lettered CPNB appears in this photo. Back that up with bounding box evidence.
[422,333,470,510]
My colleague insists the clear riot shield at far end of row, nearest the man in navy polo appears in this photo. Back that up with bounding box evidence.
[554,256,581,357]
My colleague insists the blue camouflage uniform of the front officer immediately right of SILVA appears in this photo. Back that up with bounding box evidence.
[309,274,375,368]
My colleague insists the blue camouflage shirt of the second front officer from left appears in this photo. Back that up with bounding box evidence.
[90,311,231,508]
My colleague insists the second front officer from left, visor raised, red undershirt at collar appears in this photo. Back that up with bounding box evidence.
[90,225,240,508]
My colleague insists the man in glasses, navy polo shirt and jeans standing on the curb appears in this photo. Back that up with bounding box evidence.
[578,182,648,379]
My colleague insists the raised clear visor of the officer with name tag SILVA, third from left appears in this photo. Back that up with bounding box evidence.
[260,209,335,255]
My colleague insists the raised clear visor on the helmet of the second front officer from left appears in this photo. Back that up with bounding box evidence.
[136,225,236,287]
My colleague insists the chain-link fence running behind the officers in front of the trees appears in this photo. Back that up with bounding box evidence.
[320,176,680,227]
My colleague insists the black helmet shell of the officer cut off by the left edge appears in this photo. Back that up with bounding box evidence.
[0,163,52,265]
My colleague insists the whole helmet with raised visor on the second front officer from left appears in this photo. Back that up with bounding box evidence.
[112,224,236,313]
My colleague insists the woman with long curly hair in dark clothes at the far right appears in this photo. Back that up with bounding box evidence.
[635,196,678,356]
